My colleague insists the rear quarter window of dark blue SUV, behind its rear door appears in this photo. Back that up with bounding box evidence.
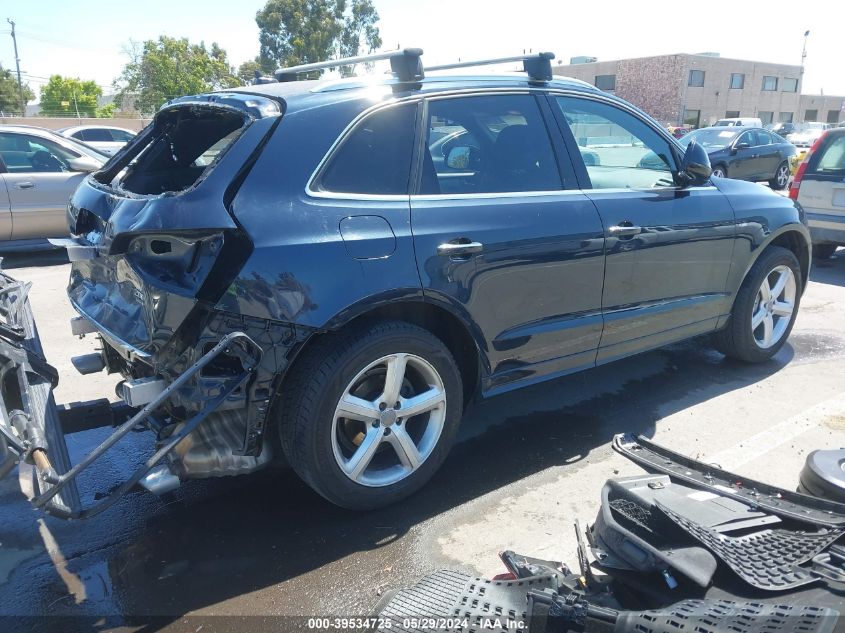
[316,103,417,195]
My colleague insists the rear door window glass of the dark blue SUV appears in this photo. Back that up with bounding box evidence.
[419,95,562,195]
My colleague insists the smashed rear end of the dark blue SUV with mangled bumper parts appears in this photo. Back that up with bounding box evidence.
[0,93,286,518]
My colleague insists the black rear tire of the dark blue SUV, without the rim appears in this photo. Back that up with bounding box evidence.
[279,321,463,510]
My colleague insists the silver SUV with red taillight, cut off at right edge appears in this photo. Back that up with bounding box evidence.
[789,127,845,259]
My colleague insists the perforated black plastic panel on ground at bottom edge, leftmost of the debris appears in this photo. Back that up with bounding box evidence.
[379,570,558,633]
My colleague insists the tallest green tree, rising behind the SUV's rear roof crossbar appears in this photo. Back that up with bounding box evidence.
[255,0,382,74]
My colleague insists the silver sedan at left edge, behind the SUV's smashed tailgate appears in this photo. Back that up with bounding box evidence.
[0,125,108,251]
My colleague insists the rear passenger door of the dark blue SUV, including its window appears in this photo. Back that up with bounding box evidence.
[411,92,604,393]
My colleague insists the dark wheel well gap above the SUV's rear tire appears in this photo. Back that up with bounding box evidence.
[288,301,479,404]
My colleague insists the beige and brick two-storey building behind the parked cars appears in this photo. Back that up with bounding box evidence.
[554,53,845,127]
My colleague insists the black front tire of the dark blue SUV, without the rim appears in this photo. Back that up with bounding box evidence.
[713,246,802,363]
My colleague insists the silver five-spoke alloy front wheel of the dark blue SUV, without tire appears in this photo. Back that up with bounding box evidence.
[751,265,796,349]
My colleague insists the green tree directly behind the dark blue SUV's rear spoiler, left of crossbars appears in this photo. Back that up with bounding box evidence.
[115,35,238,114]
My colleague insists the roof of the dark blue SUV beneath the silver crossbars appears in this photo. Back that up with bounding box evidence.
[229,73,603,112]
